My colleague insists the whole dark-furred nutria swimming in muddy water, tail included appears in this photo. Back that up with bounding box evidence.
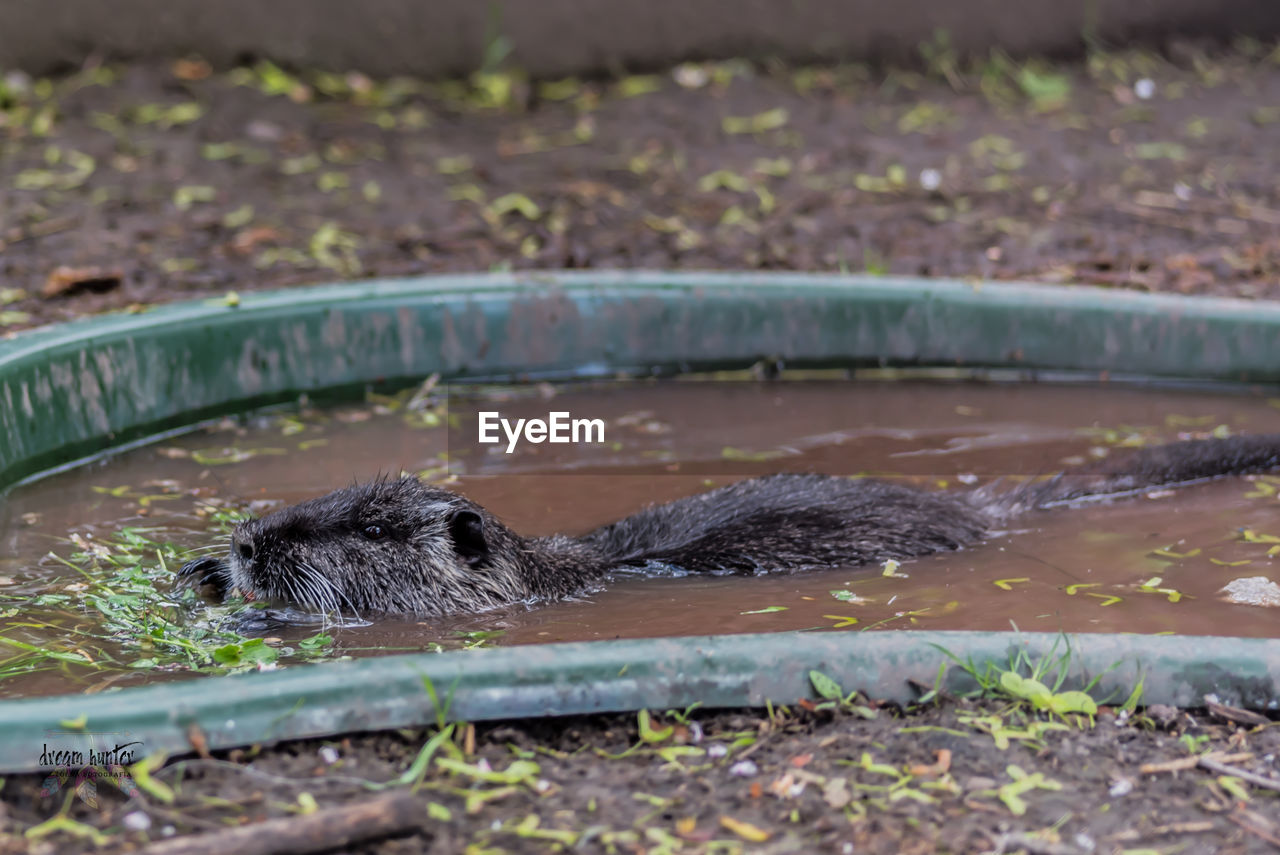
[178,434,1280,616]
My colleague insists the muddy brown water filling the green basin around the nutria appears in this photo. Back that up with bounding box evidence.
[0,381,1280,695]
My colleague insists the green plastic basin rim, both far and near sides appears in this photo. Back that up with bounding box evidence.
[0,273,1280,769]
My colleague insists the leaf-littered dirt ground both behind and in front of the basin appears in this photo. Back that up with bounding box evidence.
[0,42,1280,855]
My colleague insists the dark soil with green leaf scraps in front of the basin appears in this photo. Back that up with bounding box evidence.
[0,701,1280,855]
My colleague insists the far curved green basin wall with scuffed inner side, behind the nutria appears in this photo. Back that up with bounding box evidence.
[0,273,1280,490]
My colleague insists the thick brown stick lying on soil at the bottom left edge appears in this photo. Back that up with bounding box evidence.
[142,792,426,855]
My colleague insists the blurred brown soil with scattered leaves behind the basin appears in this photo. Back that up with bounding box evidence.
[0,45,1280,329]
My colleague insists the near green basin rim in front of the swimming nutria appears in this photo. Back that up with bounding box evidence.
[0,630,1280,771]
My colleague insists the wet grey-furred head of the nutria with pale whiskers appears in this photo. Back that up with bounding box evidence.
[208,477,530,616]
